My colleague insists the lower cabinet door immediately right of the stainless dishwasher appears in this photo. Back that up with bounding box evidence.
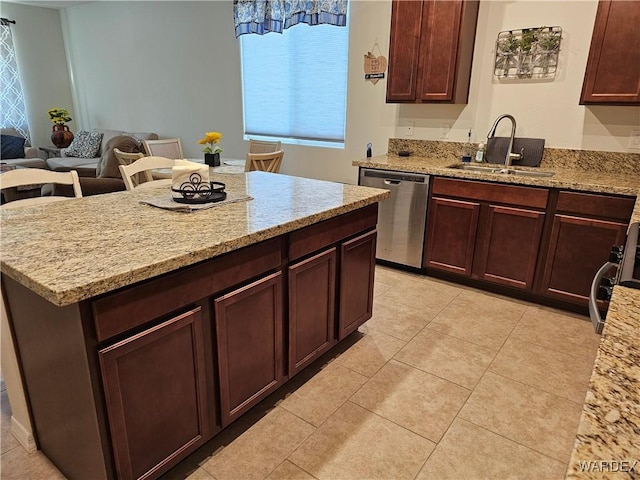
[424,197,480,276]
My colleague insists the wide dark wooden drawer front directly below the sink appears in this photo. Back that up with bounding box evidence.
[431,177,549,209]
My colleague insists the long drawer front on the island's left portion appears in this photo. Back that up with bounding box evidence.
[92,237,282,342]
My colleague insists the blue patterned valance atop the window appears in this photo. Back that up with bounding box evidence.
[233,0,348,37]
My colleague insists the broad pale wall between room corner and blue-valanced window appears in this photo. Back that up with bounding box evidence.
[63,1,244,158]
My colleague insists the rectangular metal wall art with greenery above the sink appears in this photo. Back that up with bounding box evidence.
[493,27,562,78]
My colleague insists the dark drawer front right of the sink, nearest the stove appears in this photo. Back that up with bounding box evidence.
[556,192,636,222]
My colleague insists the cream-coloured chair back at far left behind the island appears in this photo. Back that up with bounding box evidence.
[0,168,82,209]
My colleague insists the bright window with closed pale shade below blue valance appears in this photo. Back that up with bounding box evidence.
[240,21,349,147]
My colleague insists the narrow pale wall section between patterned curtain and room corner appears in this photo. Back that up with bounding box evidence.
[2,2,76,146]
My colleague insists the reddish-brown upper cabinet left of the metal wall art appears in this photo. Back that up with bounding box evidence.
[387,0,479,103]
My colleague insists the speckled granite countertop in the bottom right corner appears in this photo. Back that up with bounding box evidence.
[567,287,640,479]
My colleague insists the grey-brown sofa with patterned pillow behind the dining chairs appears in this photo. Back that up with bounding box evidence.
[43,129,158,196]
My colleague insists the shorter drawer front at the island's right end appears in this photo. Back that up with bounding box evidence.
[289,203,378,261]
